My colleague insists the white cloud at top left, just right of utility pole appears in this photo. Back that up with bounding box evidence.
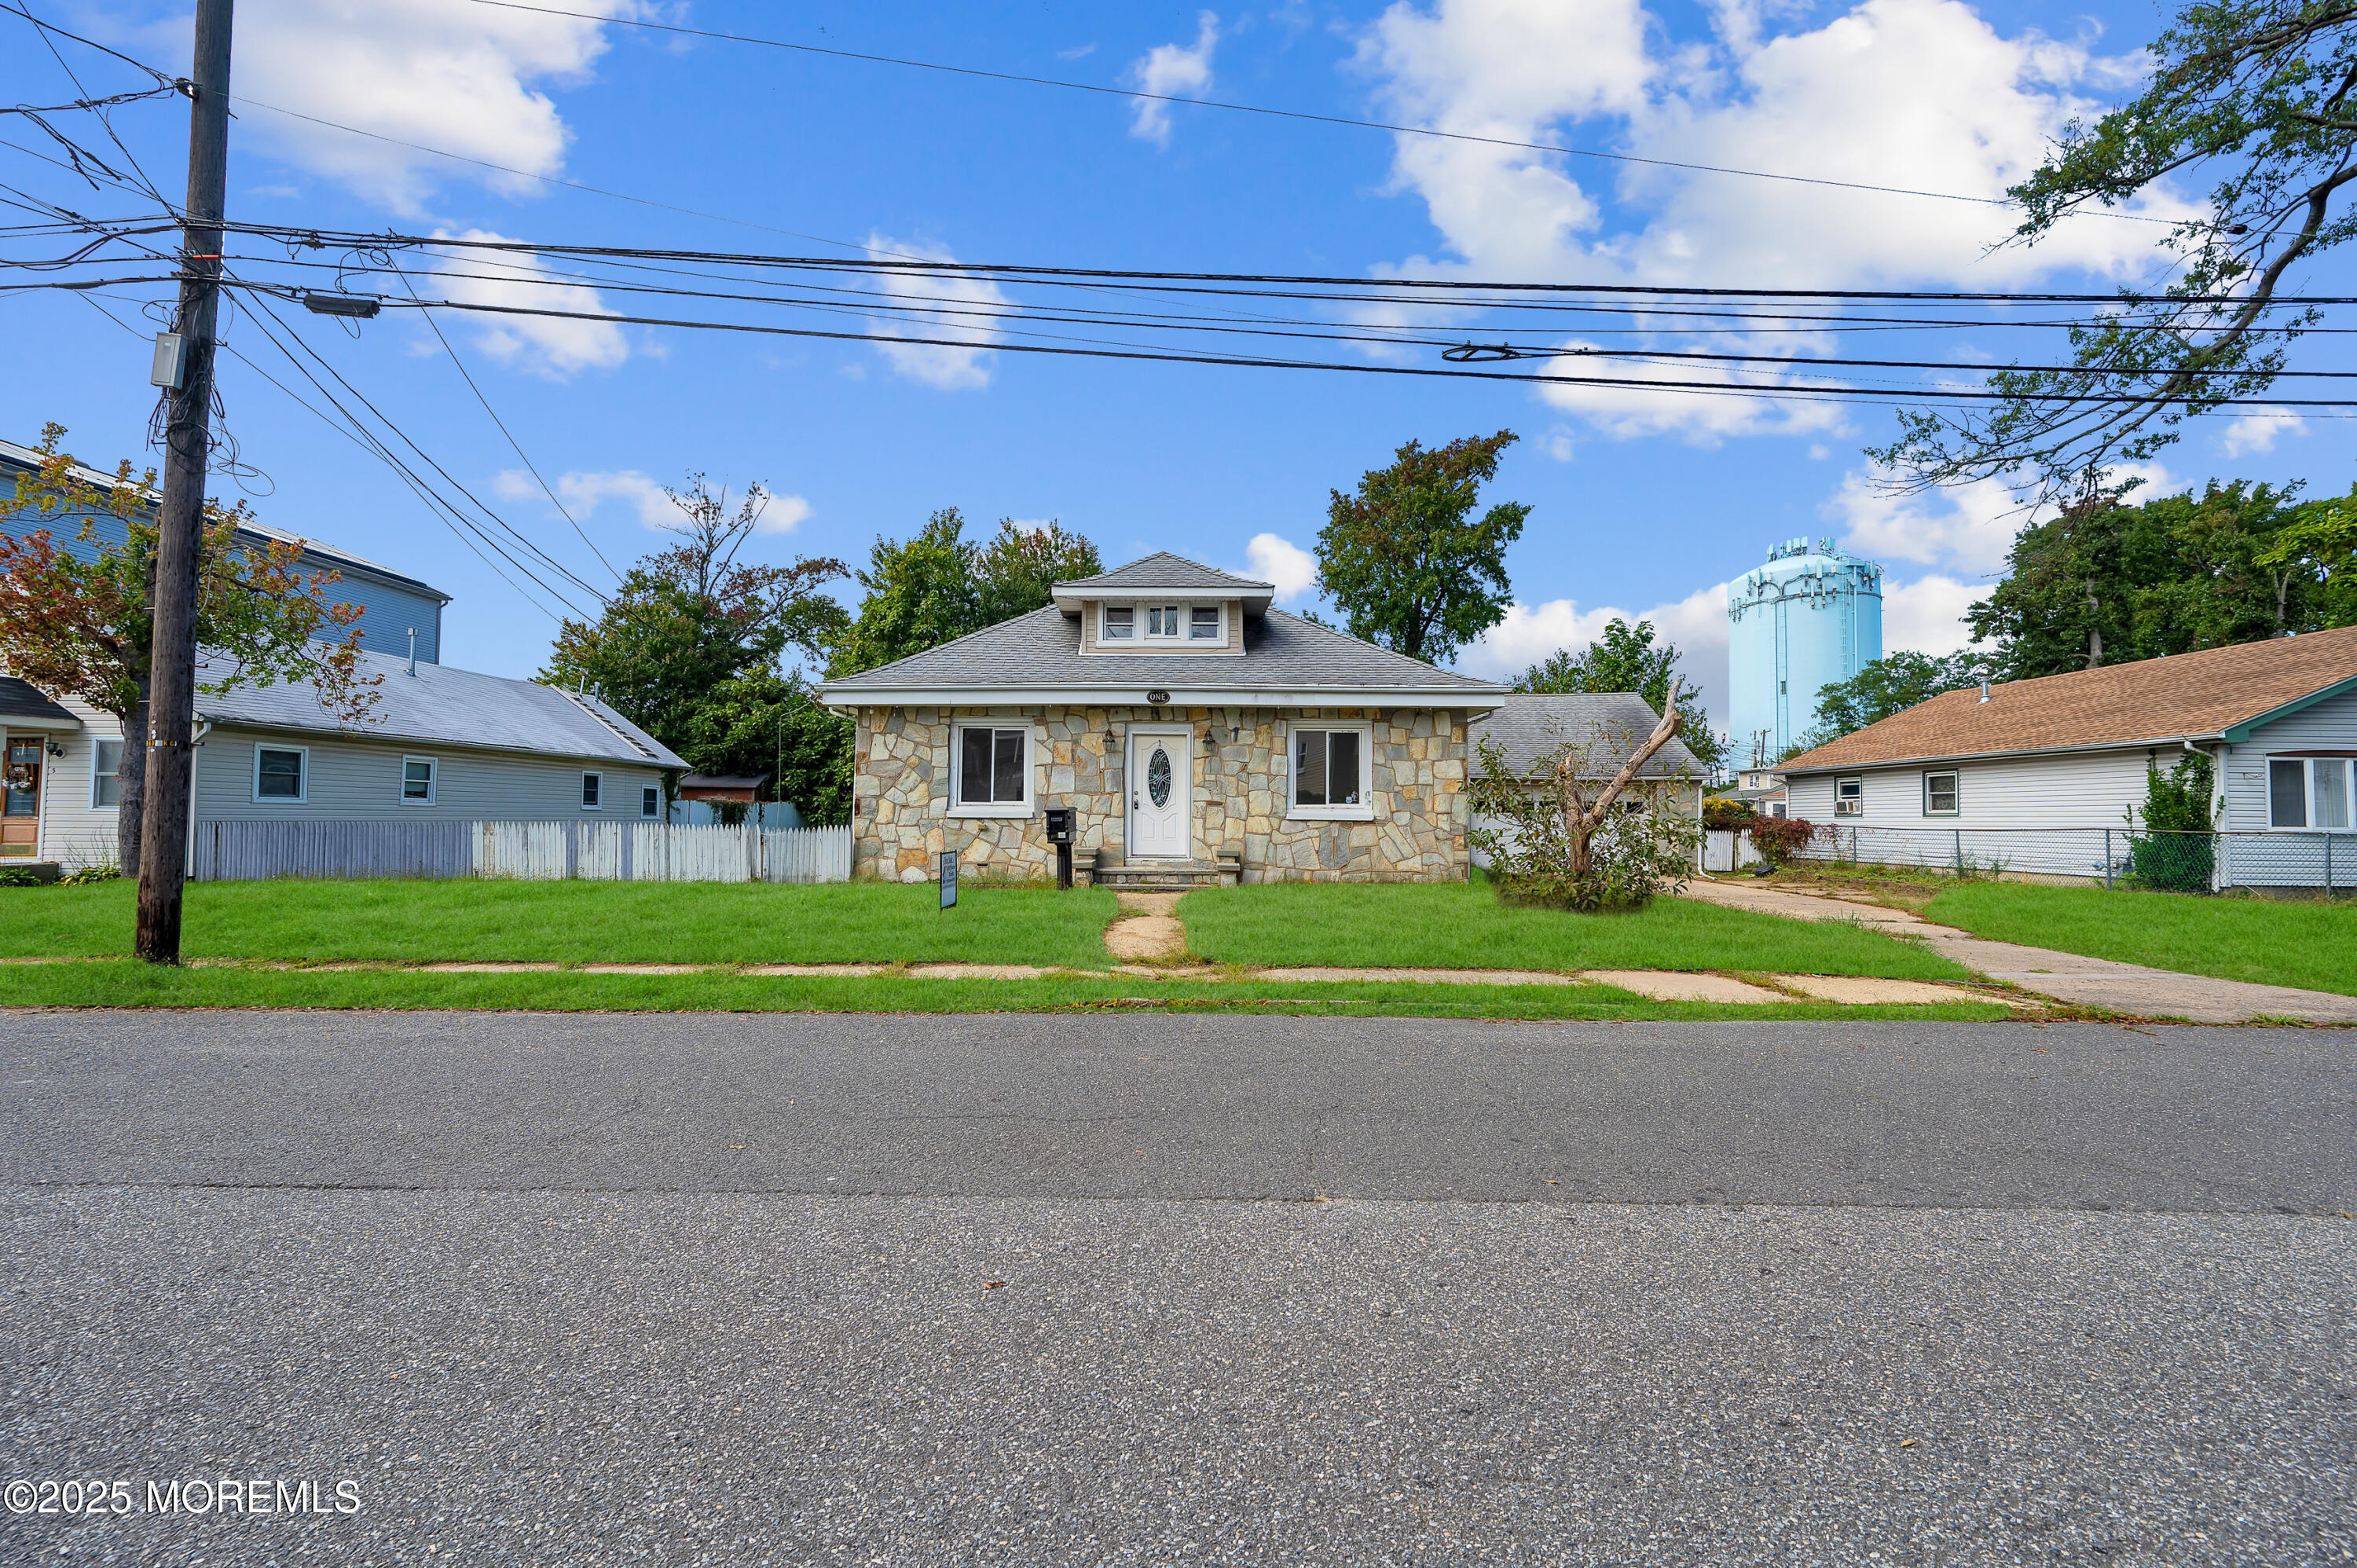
[212,0,639,217]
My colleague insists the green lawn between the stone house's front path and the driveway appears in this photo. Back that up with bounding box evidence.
[1178,882,1968,981]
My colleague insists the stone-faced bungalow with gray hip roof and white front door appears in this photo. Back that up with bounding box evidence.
[820,554,1504,887]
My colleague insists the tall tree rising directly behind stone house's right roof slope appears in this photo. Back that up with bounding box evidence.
[1318,429,1530,665]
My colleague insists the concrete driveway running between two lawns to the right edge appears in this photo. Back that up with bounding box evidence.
[1685,880,2357,1024]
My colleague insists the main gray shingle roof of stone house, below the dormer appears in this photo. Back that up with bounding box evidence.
[820,606,1499,702]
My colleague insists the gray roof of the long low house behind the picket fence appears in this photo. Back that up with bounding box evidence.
[196,653,688,768]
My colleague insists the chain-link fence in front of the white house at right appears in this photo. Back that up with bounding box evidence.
[1798,823,2357,894]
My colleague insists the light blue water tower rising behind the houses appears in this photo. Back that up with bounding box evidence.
[1728,540,1883,766]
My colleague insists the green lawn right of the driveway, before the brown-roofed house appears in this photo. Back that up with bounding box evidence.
[1928,882,2357,995]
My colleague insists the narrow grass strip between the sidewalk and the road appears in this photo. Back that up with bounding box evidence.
[0,960,2013,1021]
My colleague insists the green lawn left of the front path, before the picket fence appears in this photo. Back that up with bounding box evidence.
[0,882,1115,969]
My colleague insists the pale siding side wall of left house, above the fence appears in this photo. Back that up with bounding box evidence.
[196,726,662,823]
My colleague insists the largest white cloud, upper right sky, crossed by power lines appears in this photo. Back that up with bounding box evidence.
[1353,0,2192,443]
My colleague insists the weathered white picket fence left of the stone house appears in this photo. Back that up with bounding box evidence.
[191,819,851,882]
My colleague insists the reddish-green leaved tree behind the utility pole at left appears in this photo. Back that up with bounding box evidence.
[0,424,384,877]
